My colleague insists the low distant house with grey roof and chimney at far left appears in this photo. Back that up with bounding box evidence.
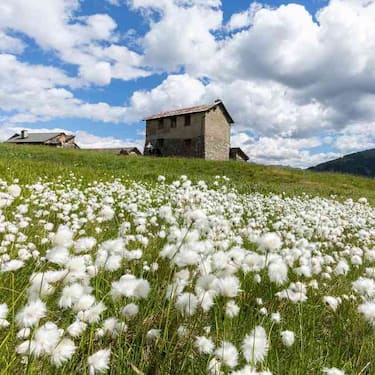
[5,130,79,148]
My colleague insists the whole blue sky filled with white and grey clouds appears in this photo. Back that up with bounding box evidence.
[0,0,375,168]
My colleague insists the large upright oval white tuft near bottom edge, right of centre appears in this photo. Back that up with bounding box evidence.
[242,326,269,364]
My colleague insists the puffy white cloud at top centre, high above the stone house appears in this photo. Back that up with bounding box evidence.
[131,0,223,74]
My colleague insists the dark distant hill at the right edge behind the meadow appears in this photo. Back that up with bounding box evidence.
[311,149,375,177]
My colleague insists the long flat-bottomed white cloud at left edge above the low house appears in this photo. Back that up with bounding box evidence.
[0,54,126,123]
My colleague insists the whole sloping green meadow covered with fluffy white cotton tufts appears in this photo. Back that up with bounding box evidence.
[0,145,375,375]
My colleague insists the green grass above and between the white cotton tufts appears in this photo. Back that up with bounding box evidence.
[0,145,375,375]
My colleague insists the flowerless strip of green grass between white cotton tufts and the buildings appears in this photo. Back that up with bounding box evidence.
[0,144,375,203]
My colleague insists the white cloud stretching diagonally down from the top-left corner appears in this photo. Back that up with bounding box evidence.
[0,0,148,85]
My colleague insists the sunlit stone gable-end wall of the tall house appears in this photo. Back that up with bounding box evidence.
[204,106,230,160]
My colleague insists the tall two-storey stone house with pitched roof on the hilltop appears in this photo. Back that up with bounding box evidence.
[144,100,234,160]
